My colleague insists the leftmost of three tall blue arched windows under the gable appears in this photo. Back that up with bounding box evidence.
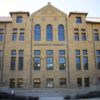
[34,24,41,41]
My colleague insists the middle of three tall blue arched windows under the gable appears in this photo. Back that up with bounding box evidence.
[46,24,53,41]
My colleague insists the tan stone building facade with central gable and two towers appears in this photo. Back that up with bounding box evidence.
[0,3,100,89]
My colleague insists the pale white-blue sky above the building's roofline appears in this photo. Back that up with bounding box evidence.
[0,0,100,17]
